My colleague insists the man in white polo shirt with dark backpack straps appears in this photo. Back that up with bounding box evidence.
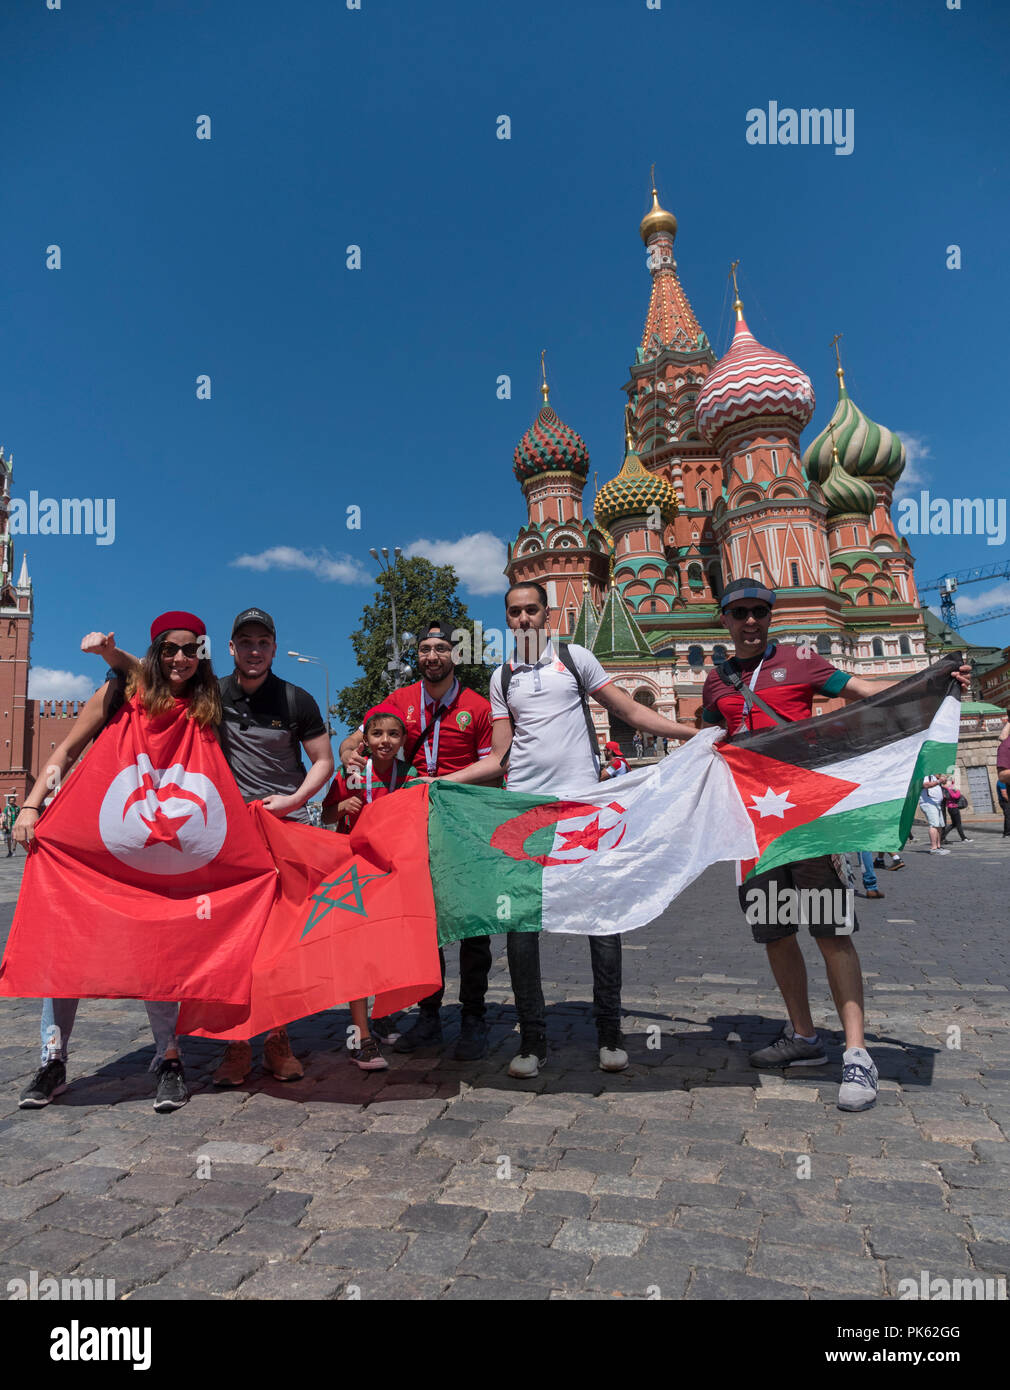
[446,584,696,1077]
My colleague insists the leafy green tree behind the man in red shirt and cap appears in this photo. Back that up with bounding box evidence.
[336,555,493,728]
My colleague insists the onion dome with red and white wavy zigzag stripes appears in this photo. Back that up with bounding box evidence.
[695,313,814,445]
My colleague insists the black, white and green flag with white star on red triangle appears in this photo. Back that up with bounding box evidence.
[720,653,961,878]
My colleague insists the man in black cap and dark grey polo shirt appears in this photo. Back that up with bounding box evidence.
[214,607,333,1086]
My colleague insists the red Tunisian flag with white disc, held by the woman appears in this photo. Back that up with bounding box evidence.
[0,699,276,1004]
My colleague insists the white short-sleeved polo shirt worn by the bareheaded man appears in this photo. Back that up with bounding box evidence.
[490,642,610,794]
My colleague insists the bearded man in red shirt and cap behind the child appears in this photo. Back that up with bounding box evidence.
[340,619,492,1062]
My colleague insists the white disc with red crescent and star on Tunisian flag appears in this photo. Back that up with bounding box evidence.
[99,753,228,874]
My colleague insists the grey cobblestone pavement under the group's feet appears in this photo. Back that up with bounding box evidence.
[0,827,1010,1300]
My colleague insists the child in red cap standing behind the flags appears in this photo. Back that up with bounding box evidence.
[322,705,418,1072]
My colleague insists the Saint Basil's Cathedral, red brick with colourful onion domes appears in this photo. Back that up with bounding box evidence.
[506,188,931,749]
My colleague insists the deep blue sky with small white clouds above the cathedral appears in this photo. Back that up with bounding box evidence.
[0,0,1010,717]
